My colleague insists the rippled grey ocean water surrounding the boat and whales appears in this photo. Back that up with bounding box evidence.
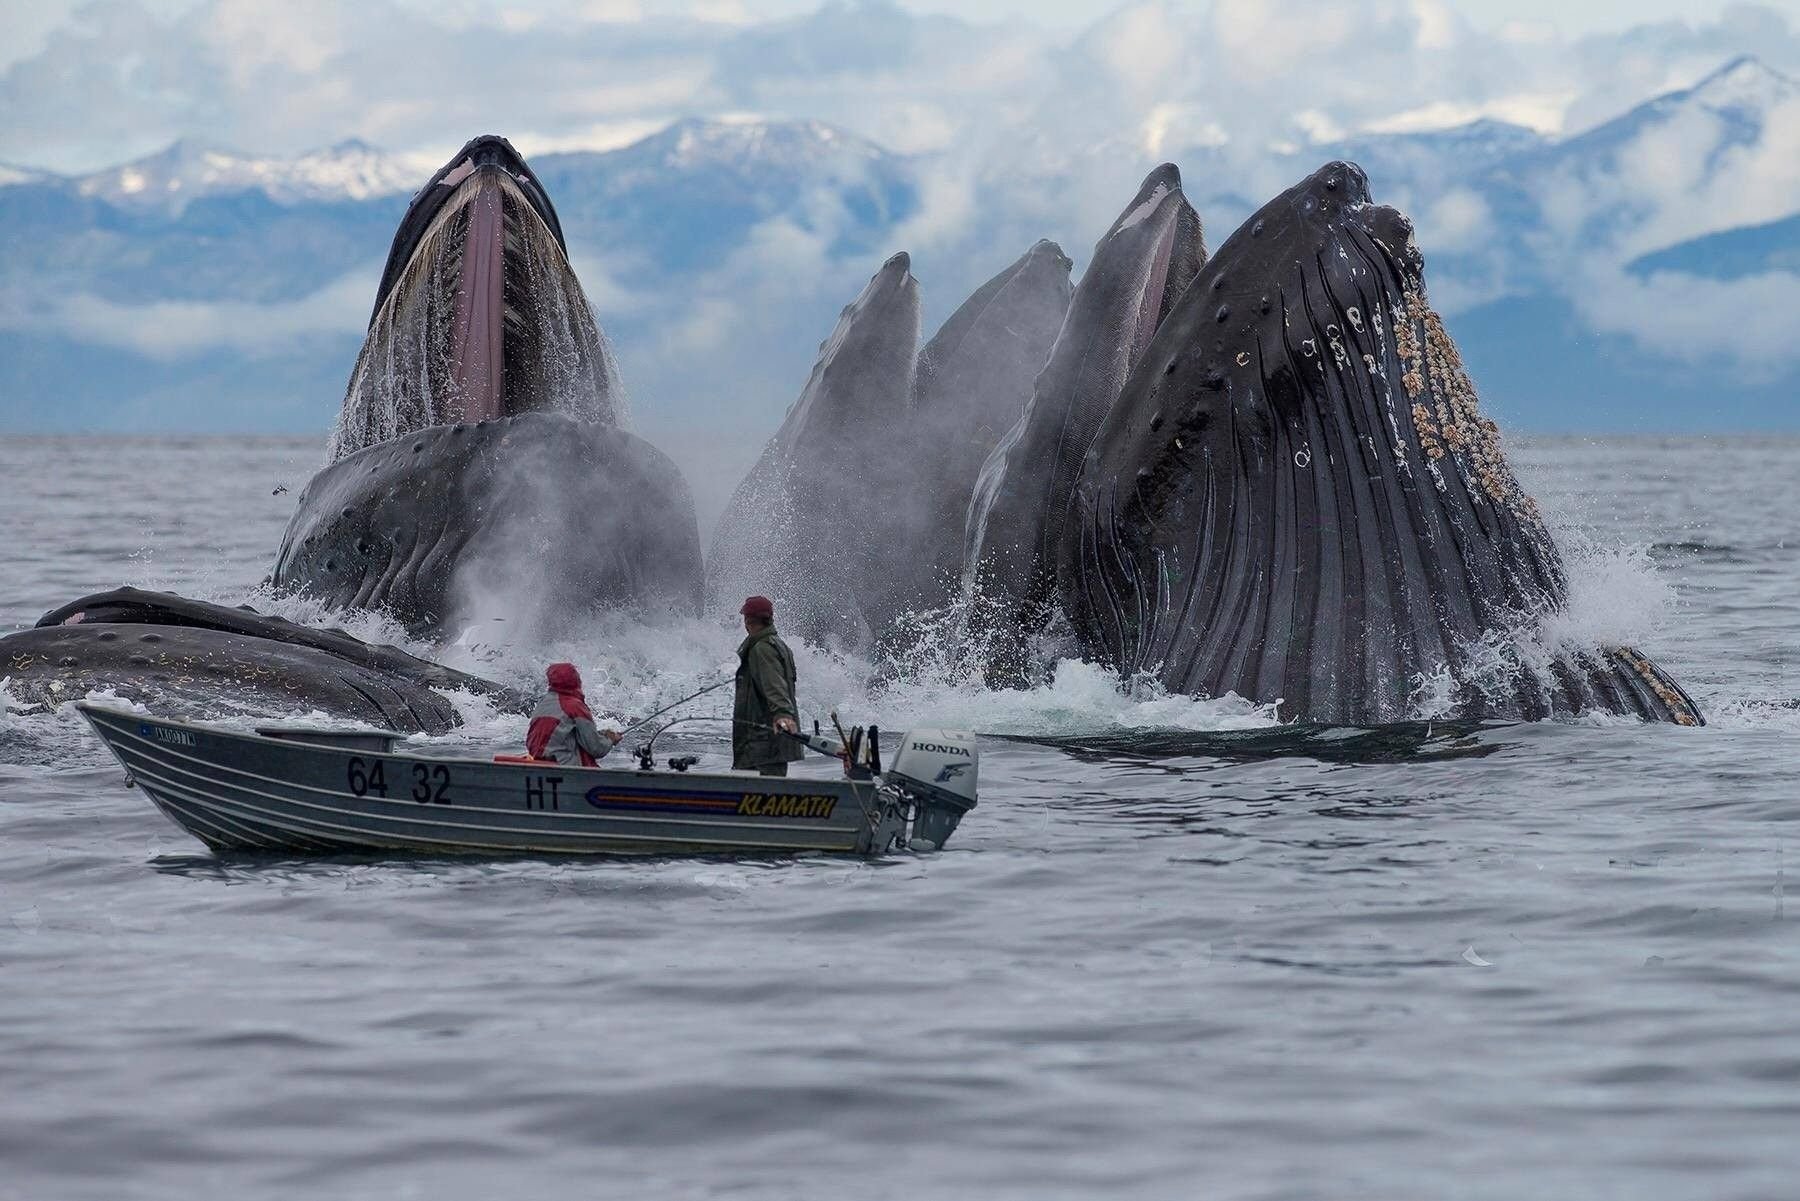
[0,438,1800,1201]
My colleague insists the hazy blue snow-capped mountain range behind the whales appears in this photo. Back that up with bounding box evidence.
[0,59,1800,437]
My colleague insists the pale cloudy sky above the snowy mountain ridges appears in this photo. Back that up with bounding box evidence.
[0,0,1800,171]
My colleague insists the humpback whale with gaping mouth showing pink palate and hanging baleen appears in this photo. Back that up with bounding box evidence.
[272,135,702,637]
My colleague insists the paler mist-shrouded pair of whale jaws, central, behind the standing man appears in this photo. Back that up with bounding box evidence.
[707,241,1069,648]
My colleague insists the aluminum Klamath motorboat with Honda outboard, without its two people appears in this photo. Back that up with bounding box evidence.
[76,700,977,855]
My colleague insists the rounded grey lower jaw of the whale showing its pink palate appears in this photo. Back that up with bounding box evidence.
[274,412,702,639]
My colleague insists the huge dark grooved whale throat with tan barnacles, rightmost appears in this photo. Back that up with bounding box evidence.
[1044,162,1701,726]
